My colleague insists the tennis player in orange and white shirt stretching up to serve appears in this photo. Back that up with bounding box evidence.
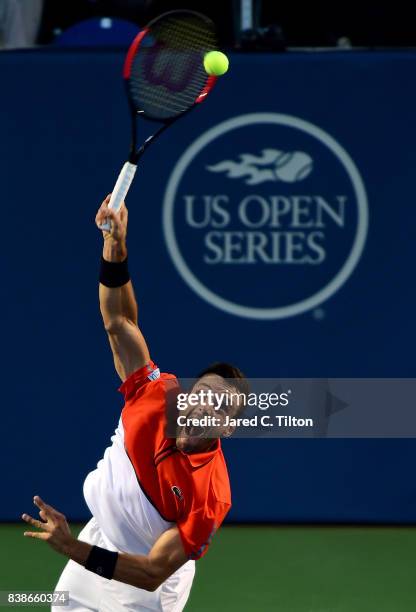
[22,196,247,612]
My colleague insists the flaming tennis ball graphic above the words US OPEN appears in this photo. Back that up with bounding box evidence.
[206,149,313,185]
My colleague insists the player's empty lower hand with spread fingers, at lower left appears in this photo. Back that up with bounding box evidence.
[22,495,75,555]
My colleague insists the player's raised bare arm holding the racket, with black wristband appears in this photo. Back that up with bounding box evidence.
[95,196,150,381]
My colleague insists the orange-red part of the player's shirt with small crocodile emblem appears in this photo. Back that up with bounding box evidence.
[120,362,231,559]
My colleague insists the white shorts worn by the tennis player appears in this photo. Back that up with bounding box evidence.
[51,518,195,612]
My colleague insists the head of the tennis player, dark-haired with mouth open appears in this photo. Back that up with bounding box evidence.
[176,362,249,453]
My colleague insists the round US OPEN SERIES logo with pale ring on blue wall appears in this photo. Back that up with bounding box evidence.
[163,113,368,320]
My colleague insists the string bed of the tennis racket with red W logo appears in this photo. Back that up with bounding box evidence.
[129,14,217,120]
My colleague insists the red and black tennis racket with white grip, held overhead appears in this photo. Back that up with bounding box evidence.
[101,10,218,231]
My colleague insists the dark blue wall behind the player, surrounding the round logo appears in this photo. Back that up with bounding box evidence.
[0,51,416,522]
